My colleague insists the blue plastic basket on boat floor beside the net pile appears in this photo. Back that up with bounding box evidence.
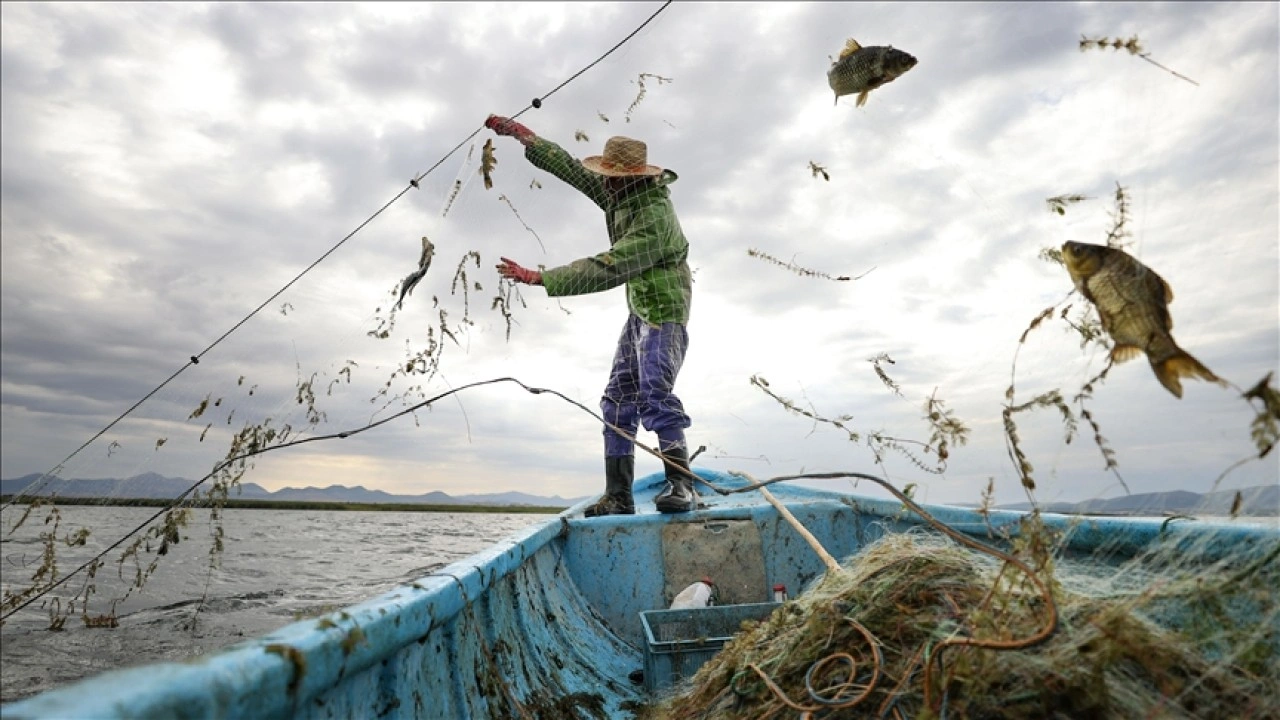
[640,602,782,692]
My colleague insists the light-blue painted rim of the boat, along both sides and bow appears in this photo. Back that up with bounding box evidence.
[3,469,1280,720]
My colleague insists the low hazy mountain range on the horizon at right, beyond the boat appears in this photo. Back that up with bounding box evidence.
[1001,486,1280,518]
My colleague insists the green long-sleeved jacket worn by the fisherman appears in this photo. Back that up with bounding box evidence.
[525,138,694,325]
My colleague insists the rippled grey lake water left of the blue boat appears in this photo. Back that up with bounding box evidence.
[0,506,552,702]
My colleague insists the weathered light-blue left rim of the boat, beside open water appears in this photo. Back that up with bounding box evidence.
[3,514,566,720]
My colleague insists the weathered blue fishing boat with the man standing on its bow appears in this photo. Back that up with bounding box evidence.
[3,469,1280,720]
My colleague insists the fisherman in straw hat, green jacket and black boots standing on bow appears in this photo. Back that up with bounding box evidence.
[485,115,698,518]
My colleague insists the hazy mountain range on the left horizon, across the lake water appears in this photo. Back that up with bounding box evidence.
[0,473,582,507]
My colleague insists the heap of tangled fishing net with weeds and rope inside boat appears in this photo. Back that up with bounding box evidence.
[645,525,1280,720]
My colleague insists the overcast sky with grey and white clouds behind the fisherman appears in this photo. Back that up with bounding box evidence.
[0,3,1280,502]
